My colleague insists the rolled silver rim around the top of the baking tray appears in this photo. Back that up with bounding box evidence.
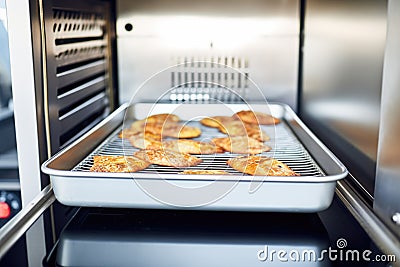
[41,102,348,183]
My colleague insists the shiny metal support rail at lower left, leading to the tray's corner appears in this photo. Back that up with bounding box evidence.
[0,185,55,258]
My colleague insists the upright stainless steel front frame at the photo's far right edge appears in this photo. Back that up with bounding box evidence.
[374,1,400,238]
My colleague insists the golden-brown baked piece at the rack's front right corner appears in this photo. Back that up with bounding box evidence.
[227,156,299,176]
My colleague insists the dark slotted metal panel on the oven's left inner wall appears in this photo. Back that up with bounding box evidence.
[43,1,113,153]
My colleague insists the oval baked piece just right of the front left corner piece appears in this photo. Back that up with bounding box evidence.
[134,149,202,167]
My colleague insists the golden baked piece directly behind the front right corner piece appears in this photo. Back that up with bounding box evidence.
[212,136,271,154]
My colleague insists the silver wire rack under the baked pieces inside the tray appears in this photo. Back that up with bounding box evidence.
[72,122,325,176]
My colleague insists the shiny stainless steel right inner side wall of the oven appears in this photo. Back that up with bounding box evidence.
[301,0,387,194]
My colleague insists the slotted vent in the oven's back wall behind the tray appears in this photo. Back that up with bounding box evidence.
[169,56,250,103]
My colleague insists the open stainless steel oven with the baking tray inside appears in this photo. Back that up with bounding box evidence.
[0,0,400,266]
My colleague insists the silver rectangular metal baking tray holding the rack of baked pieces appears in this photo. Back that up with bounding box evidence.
[42,103,347,212]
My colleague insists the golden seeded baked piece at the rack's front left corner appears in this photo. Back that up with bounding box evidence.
[90,156,151,172]
